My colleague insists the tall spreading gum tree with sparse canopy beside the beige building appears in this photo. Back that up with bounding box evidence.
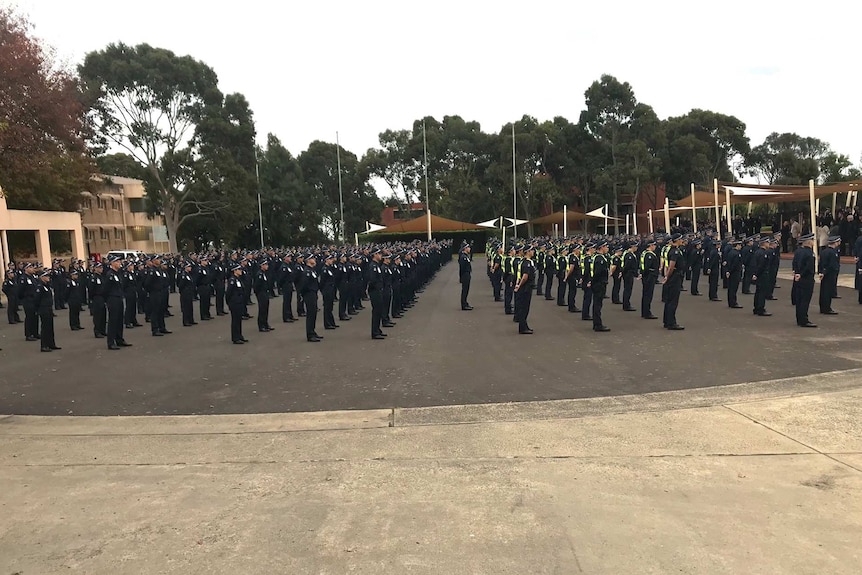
[79,43,253,251]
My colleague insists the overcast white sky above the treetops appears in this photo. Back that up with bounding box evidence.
[8,0,862,179]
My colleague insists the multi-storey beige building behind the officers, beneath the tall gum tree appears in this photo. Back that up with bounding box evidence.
[81,174,168,255]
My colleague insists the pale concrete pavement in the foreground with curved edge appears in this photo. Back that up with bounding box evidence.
[0,369,862,575]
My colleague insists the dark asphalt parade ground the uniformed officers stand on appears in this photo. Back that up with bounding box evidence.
[0,256,862,415]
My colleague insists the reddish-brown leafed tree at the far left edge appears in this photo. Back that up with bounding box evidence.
[0,8,93,210]
